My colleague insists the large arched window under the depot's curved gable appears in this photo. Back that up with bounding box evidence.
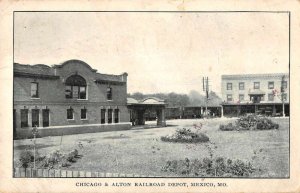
[65,75,86,99]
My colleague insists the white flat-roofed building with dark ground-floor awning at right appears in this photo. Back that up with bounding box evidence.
[222,73,289,116]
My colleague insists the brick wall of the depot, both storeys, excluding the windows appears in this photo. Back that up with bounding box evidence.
[14,61,130,128]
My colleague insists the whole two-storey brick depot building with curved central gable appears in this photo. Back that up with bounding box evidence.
[13,60,130,137]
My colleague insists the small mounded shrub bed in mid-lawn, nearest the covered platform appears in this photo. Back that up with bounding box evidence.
[161,128,209,143]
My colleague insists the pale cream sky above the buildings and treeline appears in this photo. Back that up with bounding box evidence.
[14,12,289,94]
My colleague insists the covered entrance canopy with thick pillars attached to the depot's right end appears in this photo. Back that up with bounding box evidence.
[127,97,167,127]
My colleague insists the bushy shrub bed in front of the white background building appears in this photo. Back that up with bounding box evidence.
[219,115,279,131]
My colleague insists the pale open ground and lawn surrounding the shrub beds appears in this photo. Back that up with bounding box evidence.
[14,118,289,177]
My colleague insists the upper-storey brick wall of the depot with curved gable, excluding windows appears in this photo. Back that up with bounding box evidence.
[14,63,127,105]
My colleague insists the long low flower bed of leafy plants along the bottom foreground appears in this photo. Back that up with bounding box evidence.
[162,157,255,177]
